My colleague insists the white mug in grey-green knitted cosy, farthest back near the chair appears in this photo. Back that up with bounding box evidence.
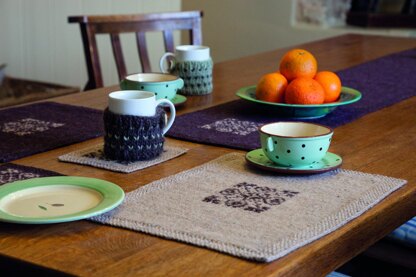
[159,45,213,95]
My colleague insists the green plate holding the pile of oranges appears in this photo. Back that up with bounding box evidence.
[236,86,361,119]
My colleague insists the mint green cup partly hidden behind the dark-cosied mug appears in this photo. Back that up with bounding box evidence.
[120,73,183,100]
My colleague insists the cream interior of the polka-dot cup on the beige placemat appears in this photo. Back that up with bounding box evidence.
[261,122,332,137]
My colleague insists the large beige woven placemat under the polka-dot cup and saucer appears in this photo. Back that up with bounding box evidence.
[92,153,406,261]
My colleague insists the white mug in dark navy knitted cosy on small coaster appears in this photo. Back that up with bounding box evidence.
[104,90,176,162]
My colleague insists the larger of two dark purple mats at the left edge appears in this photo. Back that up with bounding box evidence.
[0,102,103,162]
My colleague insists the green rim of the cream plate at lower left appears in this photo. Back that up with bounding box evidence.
[0,176,125,224]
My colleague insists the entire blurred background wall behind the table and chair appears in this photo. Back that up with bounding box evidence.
[0,0,416,88]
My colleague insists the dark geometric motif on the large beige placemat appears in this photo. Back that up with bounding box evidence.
[202,182,299,213]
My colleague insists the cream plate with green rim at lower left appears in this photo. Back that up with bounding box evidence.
[0,176,124,224]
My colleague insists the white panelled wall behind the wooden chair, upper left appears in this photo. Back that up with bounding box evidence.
[0,0,181,87]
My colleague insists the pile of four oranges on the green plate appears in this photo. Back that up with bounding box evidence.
[256,49,341,105]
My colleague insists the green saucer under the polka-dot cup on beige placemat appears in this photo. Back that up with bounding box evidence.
[246,148,342,174]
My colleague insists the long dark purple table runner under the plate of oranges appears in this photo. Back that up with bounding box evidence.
[167,46,416,150]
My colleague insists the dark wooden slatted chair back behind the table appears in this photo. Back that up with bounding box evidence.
[68,11,203,90]
